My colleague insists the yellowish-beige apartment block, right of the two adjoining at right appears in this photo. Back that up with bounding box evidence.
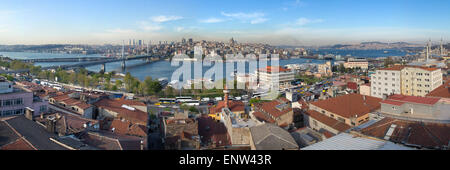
[401,66,442,97]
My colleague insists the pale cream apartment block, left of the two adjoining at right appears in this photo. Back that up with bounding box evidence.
[371,66,405,98]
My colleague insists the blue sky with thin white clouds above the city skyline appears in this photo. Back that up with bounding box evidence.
[0,0,450,46]
